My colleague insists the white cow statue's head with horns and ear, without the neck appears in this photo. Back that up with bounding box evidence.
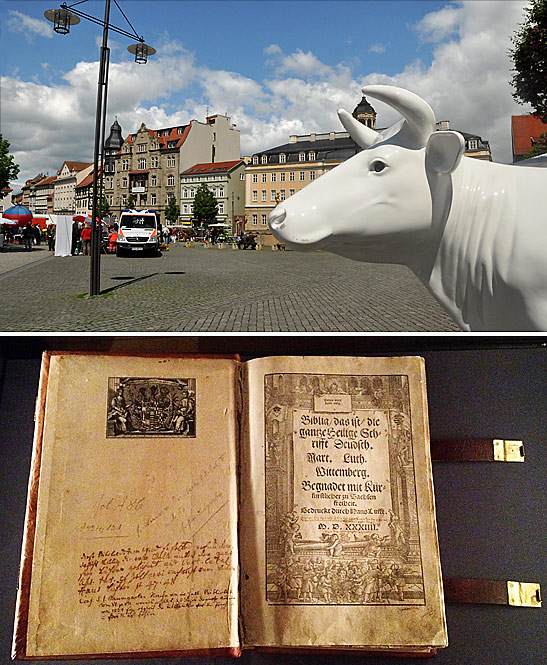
[268,85,464,263]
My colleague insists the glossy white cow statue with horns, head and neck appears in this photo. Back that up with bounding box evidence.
[269,85,547,331]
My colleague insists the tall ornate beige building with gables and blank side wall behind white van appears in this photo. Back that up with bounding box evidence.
[104,115,240,226]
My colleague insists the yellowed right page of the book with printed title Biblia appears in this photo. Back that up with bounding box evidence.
[240,357,447,650]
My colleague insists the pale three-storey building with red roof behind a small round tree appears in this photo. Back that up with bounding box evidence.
[180,159,245,234]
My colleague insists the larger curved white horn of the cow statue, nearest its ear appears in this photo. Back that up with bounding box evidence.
[363,85,435,149]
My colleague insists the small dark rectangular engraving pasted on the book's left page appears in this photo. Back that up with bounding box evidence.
[106,377,196,438]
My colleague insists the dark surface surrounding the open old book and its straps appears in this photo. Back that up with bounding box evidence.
[0,334,547,665]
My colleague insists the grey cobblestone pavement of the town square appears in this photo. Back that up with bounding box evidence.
[0,244,458,333]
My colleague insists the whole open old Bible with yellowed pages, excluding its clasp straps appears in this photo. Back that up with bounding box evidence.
[13,353,447,659]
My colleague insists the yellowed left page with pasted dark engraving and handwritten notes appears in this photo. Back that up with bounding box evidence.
[26,355,238,657]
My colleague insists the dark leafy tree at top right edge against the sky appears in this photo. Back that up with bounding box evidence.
[509,0,547,123]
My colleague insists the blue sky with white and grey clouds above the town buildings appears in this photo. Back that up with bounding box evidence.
[0,0,530,189]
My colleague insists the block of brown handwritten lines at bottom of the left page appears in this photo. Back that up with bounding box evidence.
[77,539,235,620]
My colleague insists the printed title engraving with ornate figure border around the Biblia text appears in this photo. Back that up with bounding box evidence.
[264,373,425,605]
